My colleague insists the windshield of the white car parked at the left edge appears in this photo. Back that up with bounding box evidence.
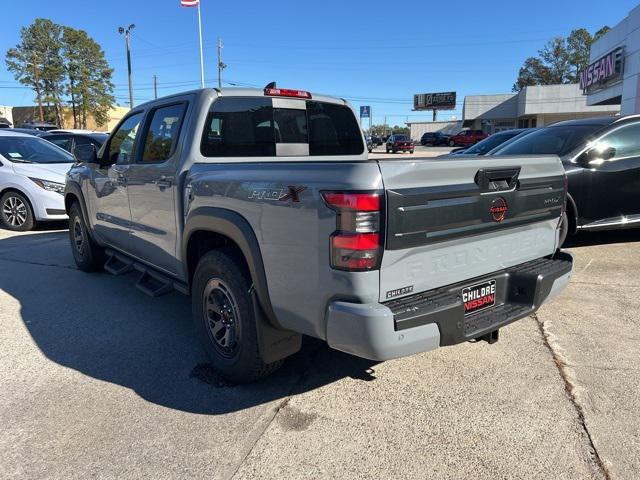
[0,136,75,163]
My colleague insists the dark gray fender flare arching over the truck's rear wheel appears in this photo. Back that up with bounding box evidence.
[182,207,282,328]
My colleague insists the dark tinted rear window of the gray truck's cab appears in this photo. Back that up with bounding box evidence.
[200,97,364,157]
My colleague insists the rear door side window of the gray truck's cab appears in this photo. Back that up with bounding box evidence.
[142,104,185,163]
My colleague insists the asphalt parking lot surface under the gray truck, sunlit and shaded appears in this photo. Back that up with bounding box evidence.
[0,219,640,479]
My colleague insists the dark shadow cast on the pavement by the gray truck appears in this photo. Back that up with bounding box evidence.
[0,231,375,415]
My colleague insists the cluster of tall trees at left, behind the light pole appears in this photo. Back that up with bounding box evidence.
[5,18,115,128]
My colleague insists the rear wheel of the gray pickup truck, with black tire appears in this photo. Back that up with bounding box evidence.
[191,250,283,383]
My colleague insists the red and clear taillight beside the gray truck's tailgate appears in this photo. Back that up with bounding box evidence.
[322,192,384,272]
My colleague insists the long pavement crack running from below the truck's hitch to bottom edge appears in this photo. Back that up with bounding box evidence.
[531,313,611,480]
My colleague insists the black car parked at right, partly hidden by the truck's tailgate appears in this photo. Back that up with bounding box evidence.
[492,115,640,244]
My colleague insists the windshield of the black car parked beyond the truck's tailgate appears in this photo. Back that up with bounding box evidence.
[493,125,602,156]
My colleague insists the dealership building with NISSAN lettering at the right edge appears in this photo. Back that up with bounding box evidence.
[580,6,640,115]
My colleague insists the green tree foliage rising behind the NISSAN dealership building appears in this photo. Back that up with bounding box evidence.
[513,26,610,92]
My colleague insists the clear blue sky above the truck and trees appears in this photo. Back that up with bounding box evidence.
[0,0,637,124]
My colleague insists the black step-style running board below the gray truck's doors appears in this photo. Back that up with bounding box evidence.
[104,249,189,297]
